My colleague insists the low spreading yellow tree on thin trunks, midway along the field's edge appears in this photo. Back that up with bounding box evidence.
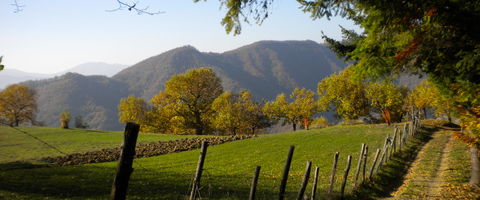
[263,88,316,131]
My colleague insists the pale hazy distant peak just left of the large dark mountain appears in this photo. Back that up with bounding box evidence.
[56,62,128,77]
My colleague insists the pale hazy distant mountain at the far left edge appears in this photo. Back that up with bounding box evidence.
[0,68,51,89]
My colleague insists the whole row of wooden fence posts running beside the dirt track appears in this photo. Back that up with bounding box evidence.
[111,118,420,200]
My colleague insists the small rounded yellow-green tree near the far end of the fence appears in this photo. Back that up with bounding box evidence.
[365,81,404,125]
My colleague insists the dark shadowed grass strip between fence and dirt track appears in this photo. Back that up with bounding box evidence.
[346,126,438,199]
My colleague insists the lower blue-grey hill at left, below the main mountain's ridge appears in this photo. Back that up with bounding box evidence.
[24,73,129,130]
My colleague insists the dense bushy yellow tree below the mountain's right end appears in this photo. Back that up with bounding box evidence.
[318,68,369,120]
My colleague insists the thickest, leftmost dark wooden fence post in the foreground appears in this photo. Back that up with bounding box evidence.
[110,122,140,200]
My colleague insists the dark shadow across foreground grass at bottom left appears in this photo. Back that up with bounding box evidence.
[0,163,276,199]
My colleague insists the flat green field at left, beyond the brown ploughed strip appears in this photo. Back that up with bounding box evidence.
[0,126,200,163]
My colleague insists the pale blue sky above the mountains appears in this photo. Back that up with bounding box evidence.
[0,0,360,74]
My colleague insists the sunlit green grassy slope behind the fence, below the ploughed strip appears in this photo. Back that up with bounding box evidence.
[0,125,392,199]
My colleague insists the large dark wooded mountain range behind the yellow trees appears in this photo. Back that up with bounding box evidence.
[26,41,346,130]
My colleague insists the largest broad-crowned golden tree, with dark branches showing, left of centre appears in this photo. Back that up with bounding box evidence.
[149,67,223,135]
